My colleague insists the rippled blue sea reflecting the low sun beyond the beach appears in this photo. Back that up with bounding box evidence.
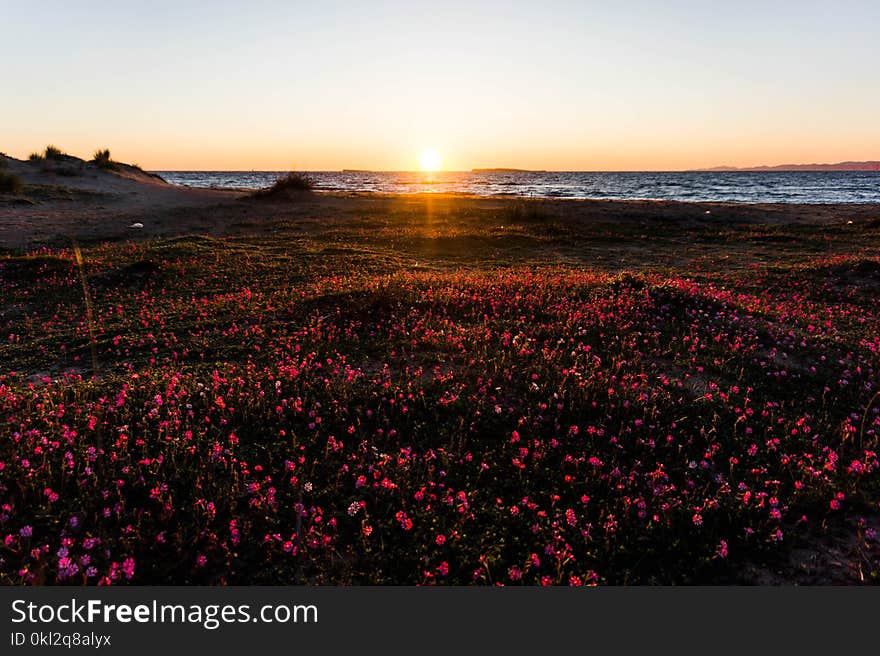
[156,171,880,203]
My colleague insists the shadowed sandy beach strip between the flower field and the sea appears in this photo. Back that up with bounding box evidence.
[0,156,880,251]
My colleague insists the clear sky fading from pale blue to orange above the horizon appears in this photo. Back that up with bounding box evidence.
[0,0,880,170]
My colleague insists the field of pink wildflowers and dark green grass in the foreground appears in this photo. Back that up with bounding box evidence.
[0,205,880,585]
